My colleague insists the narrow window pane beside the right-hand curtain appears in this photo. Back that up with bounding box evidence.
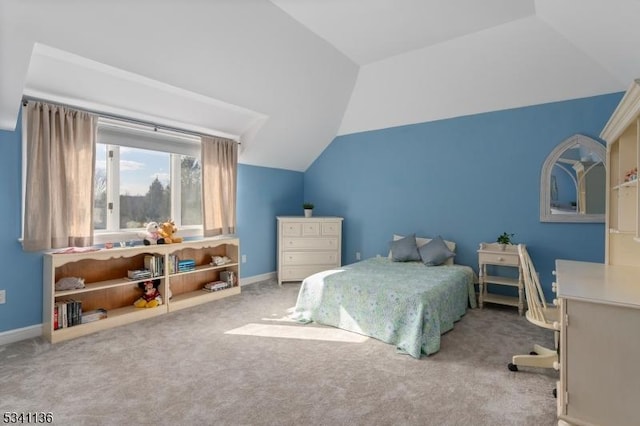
[180,155,202,225]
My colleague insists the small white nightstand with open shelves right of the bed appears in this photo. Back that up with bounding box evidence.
[478,243,524,315]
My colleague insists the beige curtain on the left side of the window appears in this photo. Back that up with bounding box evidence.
[23,102,96,251]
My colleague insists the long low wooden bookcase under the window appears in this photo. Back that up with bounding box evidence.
[43,237,240,343]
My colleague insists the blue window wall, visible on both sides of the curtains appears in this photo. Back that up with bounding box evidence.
[0,115,303,333]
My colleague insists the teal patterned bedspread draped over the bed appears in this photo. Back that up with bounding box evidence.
[292,257,476,358]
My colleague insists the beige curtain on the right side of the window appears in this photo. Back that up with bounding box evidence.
[202,136,238,237]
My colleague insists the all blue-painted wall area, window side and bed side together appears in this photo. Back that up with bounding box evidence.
[0,93,622,332]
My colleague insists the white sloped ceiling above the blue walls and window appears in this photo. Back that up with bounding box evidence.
[0,0,640,171]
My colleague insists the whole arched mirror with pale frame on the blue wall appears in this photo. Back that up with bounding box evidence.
[540,135,606,222]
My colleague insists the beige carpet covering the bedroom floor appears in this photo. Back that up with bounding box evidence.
[0,282,557,426]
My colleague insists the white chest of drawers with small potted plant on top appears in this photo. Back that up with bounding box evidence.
[277,216,343,285]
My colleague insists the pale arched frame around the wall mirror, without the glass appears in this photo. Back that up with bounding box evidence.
[540,135,607,223]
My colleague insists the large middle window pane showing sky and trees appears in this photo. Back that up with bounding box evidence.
[120,147,171,229]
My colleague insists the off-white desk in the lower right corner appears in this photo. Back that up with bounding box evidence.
[556,260,640,426]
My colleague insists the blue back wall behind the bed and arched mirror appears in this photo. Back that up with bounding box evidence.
[304,93,622,297]
